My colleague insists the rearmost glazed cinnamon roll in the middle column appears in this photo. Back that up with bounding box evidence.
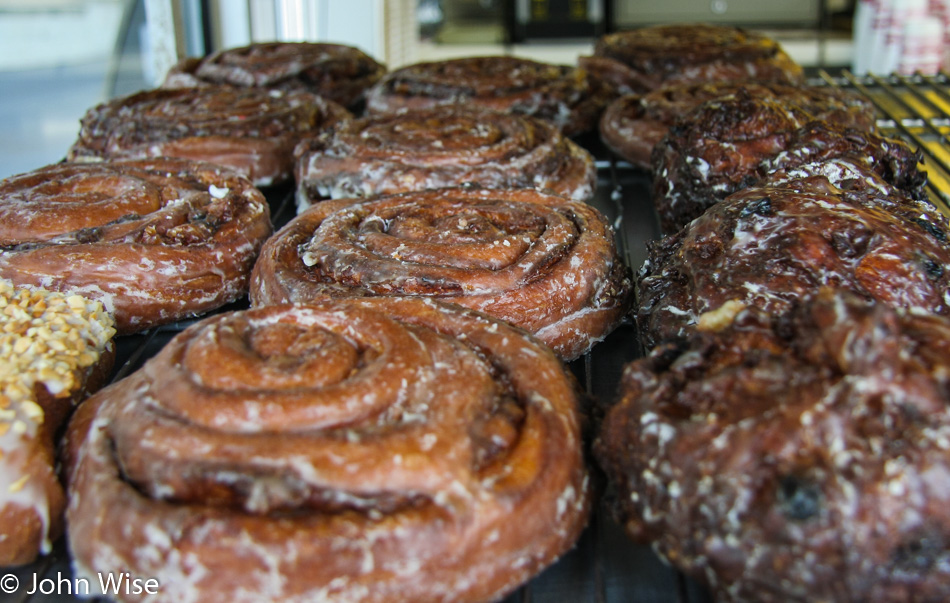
[366,56,608,136]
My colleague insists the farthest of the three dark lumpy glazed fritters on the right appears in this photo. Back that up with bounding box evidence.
[653,89,927,233]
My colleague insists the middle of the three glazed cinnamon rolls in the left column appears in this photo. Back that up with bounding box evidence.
[67,87,350,186]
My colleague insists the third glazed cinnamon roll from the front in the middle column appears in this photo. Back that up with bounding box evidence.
[295,106,597,210]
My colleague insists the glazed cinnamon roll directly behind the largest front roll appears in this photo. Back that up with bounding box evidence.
[250,189,631,359]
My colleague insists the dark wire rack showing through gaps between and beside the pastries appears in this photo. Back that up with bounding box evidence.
[0,71,950,603]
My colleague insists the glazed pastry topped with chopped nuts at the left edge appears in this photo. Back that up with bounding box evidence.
[0,279,115,566]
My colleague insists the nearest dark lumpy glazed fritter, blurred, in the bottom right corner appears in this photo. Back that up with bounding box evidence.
[595,290,950,602]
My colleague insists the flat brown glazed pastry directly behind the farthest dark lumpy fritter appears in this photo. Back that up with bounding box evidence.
[600,82,875,170]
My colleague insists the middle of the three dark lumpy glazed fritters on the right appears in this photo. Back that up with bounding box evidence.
[637,162,950,348]
